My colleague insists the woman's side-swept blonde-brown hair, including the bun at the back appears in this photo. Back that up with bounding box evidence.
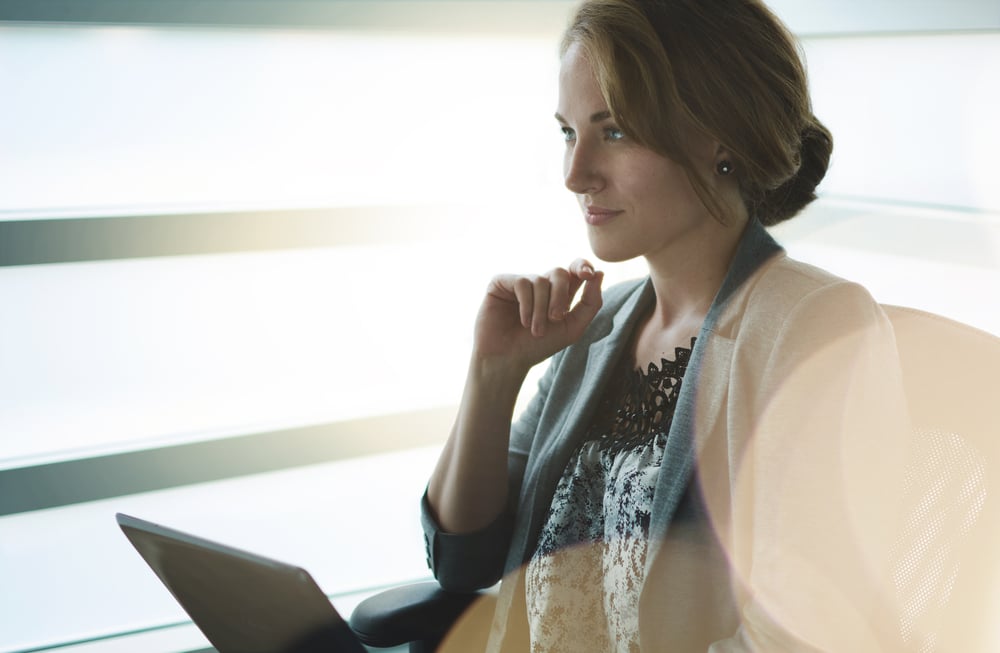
[561,0,833,225]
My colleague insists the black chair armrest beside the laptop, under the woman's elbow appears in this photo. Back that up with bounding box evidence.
[349,581,482,647]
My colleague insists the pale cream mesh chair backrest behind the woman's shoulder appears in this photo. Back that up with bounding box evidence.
[883,306,1000,653]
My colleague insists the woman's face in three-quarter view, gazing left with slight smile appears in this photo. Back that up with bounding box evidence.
[556,44,719,263]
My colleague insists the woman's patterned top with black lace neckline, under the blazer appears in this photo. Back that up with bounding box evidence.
[525,338,694,652]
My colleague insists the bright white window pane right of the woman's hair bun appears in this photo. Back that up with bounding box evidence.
[805,33,1000,212]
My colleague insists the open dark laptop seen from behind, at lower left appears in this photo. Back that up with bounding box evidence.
[116,513,367,653]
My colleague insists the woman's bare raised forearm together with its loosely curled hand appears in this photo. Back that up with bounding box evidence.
[427,259,604,534]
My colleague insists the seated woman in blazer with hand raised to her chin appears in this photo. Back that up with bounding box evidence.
[423,0,906,652]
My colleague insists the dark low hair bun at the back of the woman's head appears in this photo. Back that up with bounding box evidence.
[757,116,833,226]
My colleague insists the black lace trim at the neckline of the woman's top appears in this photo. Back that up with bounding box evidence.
[585,338,695,453]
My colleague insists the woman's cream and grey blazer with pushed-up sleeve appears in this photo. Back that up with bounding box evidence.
[423,222,909,653]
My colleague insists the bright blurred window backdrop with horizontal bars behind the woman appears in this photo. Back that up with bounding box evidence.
[0,0,1000,653]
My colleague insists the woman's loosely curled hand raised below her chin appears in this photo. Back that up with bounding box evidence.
[473,259,604,372]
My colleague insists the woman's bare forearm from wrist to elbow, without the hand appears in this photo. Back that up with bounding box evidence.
[427,355,527,533]
